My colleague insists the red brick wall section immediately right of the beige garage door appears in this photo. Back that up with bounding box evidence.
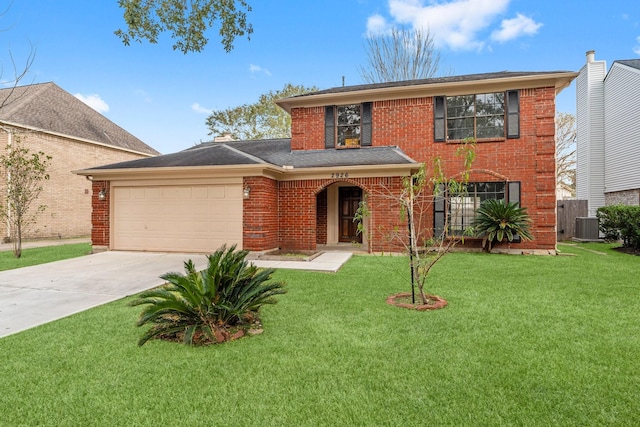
[242,176,279,251]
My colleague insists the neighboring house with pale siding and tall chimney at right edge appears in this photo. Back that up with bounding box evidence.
[576,51,640,216]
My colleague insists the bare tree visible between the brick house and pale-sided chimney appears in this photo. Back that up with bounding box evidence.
[556,112,577,192]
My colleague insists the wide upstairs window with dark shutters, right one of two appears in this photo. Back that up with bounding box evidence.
[434,91,520,141]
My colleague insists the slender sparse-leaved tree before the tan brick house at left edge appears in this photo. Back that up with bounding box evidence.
[0,135,51,258]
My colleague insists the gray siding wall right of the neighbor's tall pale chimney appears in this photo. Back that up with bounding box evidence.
[604,62,640,193]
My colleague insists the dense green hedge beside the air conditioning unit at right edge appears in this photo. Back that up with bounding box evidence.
[596,205,640,249]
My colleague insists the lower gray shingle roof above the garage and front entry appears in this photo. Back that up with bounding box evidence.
[93,139,415,170]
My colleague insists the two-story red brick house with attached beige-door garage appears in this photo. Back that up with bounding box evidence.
[76,71,577,253]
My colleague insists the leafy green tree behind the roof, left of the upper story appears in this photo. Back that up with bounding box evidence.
[206,83,318,140]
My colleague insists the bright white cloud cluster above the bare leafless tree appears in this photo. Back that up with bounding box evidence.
[367,0,542,50]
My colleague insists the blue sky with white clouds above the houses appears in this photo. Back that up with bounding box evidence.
[0,0,640,153]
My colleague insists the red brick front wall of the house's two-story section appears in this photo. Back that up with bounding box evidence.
[288,87,556,254]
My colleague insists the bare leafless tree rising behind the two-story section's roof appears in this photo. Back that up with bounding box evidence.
[359,27,440,83]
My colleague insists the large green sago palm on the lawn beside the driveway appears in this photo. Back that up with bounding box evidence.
[131,245,286,345]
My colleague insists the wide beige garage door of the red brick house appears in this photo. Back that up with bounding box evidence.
[112,184,242,253]
